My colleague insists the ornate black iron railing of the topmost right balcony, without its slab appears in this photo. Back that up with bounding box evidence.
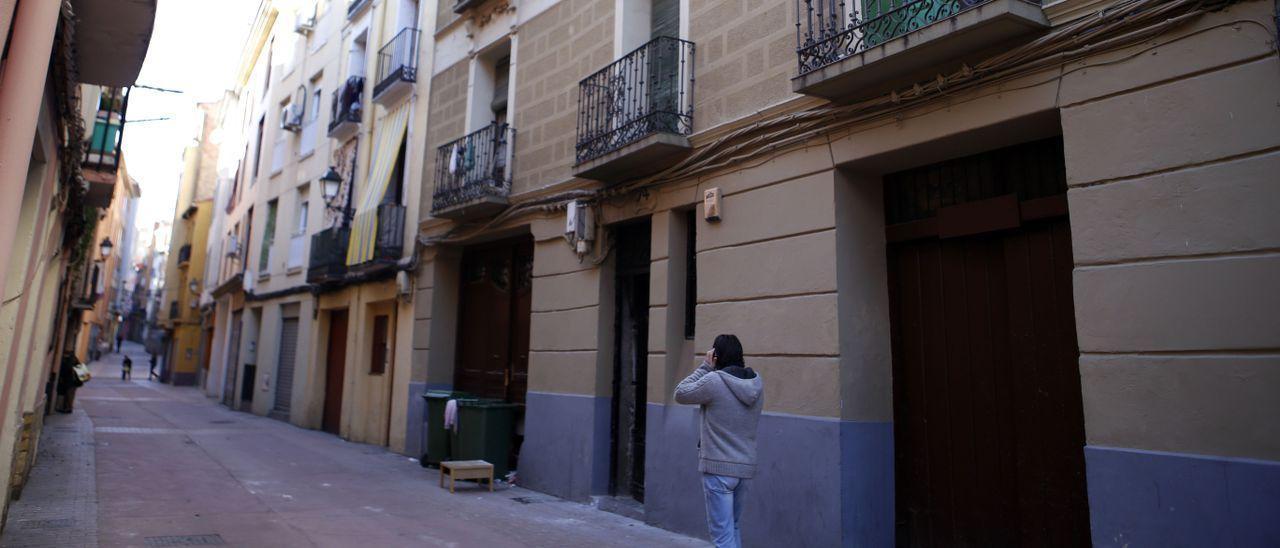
[796,0,1008,76]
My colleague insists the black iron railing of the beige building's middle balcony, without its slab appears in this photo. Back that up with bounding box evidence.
[576,37,694,164]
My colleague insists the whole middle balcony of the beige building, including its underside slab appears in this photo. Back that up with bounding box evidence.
[573,37,694,182]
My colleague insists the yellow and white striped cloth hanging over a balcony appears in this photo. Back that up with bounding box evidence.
[347,102,410,266]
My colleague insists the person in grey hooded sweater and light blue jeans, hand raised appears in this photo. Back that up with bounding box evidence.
[676,334,764,548]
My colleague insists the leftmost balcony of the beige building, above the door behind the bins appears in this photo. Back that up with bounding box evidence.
[431,123,516,220]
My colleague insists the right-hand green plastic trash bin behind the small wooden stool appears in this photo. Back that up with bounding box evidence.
[451,399,520,478]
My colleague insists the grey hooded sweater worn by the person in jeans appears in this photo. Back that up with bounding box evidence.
[676,361,764,478]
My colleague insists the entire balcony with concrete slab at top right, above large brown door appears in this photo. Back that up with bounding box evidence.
[791,0,1050,102]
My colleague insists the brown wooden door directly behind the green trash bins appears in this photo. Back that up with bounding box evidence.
[453,239,532,402]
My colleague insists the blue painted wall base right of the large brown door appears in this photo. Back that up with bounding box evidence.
[1084,446,1280,547]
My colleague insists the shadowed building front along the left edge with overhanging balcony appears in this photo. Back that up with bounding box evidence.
[0,0,155,527]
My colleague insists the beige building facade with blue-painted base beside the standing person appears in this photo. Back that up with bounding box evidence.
[407,0,1280,545]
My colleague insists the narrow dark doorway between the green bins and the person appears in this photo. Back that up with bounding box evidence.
[609,219,650,502]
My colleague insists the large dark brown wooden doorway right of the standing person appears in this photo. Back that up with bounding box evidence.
[884,138,1089,547]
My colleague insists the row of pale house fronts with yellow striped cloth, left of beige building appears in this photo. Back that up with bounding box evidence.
[206,1,425,449]
